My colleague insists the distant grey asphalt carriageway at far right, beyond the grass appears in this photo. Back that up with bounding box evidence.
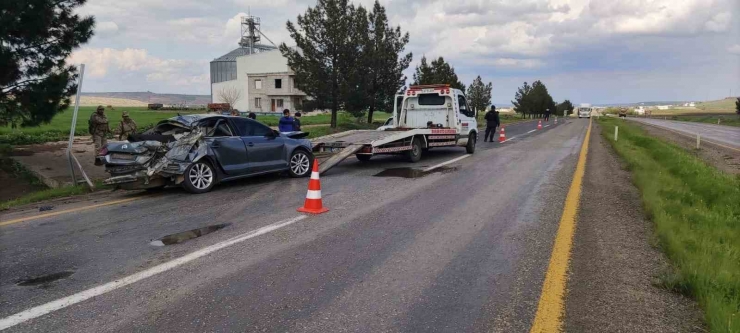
[628,118,740,148]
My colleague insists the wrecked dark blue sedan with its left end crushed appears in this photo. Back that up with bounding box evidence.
[98,115,314,193]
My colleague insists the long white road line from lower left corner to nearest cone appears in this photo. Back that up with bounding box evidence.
[0,215,307,330]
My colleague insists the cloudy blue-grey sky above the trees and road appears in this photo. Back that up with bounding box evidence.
[71,0,740,103]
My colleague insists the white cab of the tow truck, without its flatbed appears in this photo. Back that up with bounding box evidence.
[393,84,478,142]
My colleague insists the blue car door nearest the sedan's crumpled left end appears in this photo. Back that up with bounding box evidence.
[201,118,249,176]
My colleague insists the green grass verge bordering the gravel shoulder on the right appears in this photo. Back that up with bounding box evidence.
[599,117,740,333]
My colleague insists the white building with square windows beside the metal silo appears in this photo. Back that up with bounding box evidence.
[211,50,306,112]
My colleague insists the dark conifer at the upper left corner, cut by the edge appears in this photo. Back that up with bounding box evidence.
[0,0,95,127]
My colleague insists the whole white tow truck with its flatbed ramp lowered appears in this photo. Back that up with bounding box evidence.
[313,84,478,173]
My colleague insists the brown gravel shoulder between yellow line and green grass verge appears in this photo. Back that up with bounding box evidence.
[565,124,705,332]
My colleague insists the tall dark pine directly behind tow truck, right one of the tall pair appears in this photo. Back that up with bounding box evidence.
[364,0,412,123]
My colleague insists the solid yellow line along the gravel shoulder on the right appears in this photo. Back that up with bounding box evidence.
[530,120,591,333]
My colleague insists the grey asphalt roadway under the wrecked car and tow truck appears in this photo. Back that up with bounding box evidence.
[0,119,588,332]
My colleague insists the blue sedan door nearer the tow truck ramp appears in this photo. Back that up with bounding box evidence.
[232,118,288,173]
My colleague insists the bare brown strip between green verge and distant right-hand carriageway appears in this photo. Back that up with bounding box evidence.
[632,122,740,175]
